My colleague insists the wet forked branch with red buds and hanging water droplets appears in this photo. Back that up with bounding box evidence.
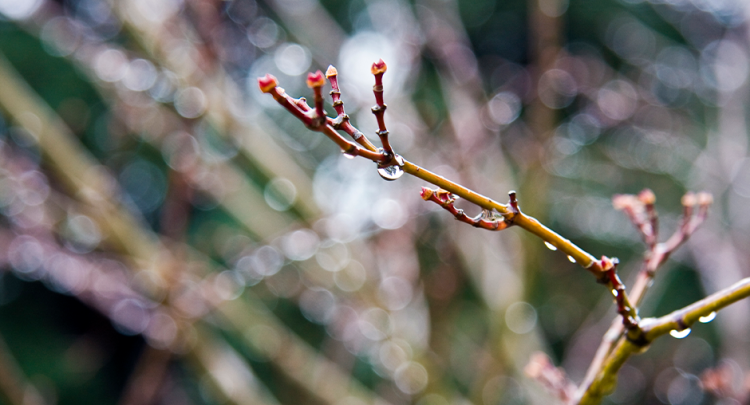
[258,60,750,404]
